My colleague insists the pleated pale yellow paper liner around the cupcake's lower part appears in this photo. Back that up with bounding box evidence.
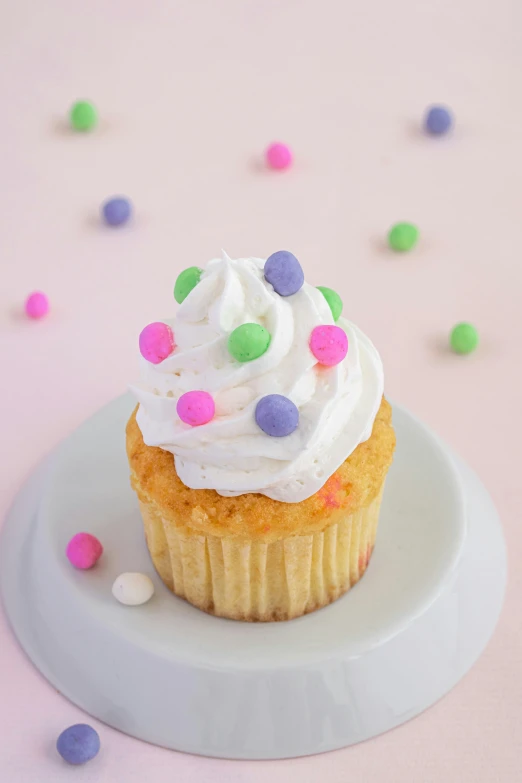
[140,485,384,621]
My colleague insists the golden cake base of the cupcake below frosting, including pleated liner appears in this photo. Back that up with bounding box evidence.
[126,398,395,622]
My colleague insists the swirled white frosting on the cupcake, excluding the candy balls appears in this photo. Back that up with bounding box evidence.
[132,254,383,503]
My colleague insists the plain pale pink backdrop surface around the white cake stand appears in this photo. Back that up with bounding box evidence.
[0,0,522,783]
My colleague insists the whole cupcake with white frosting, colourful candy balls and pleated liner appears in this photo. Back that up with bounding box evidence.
[127,251,395,621]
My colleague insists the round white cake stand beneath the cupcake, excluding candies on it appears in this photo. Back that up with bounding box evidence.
[0,397,506,759]
